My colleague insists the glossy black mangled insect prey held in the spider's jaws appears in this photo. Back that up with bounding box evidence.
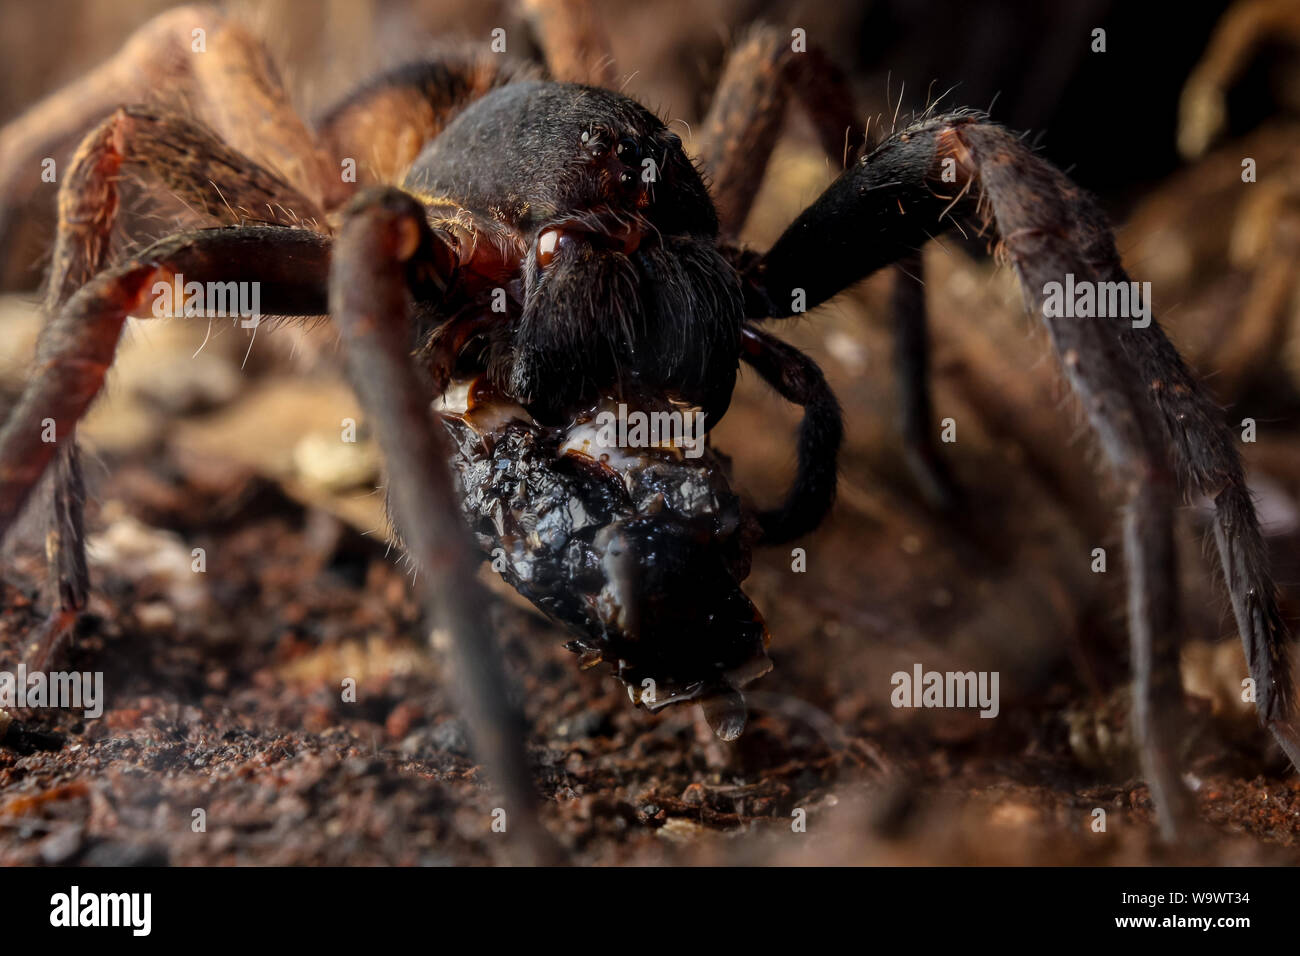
[434,378,772,740]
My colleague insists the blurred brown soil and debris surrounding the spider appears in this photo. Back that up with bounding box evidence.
[0,0,1300,864]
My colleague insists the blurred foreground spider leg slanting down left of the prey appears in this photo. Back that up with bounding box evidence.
[330,189,555,862]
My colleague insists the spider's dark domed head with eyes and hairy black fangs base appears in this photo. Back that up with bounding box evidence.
[406,82,742,424]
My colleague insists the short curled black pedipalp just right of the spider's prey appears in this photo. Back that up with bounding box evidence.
[741,325,844,544]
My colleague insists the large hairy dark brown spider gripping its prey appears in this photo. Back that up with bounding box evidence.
[0,0,1300,852]
